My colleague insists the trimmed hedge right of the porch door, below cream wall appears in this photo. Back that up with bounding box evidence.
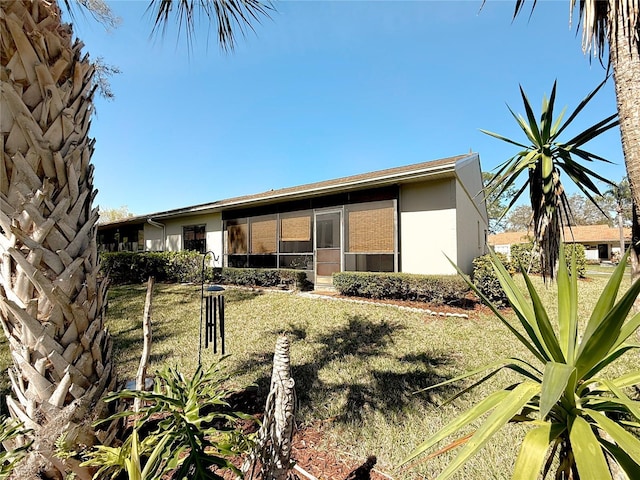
[333,272,470,305]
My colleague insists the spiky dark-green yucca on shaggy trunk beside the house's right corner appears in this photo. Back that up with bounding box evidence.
[480,80,619,278]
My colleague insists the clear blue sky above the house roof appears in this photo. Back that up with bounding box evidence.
[75,0,625,214]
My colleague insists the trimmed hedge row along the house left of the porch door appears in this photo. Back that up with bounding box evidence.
[100,251,309,289]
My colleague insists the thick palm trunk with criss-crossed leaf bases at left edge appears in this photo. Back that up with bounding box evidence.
[0,0,115,478]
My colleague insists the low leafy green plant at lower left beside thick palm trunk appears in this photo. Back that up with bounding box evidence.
[83,363,252,480]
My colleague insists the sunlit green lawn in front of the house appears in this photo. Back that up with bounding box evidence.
[0,277,640,479]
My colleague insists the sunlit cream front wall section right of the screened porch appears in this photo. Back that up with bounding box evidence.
[399,179,458,275]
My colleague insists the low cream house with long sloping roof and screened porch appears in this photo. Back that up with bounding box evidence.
[98,153,487,286]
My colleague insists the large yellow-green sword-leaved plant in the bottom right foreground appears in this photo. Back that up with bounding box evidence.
[404,248,640,480]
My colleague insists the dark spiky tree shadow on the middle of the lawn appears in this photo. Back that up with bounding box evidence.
[232,316,453,423]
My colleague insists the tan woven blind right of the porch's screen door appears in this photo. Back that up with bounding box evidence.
[348,205,394,253]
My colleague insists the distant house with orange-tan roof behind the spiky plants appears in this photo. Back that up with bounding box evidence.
[489,225,631,262]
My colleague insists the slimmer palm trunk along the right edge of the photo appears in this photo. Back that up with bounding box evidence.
[607,0,640,281]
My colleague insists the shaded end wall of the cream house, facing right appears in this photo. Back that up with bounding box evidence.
[456,157,488,273]
